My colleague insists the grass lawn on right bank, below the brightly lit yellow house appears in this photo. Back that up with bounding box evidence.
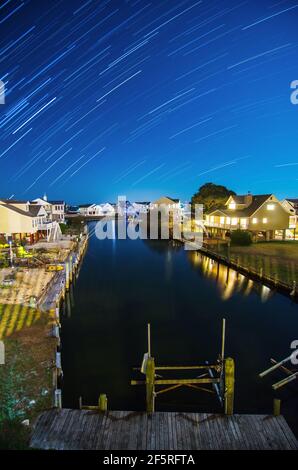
[230,241,298,284]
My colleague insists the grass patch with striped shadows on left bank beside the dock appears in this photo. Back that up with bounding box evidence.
[0,305,56,449]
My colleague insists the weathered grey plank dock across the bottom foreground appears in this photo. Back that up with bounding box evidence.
[30,408,298,450]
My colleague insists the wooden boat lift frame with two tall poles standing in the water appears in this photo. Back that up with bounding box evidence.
[131,319,235,415]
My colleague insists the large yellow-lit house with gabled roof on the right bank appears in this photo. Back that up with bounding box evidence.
[205,194,289,240]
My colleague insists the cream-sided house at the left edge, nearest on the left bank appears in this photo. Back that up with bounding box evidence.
[0,199,61,243]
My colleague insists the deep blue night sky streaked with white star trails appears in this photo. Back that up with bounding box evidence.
[0,0,298,203]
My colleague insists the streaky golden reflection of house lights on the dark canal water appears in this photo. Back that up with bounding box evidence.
[186,251,273,302]
